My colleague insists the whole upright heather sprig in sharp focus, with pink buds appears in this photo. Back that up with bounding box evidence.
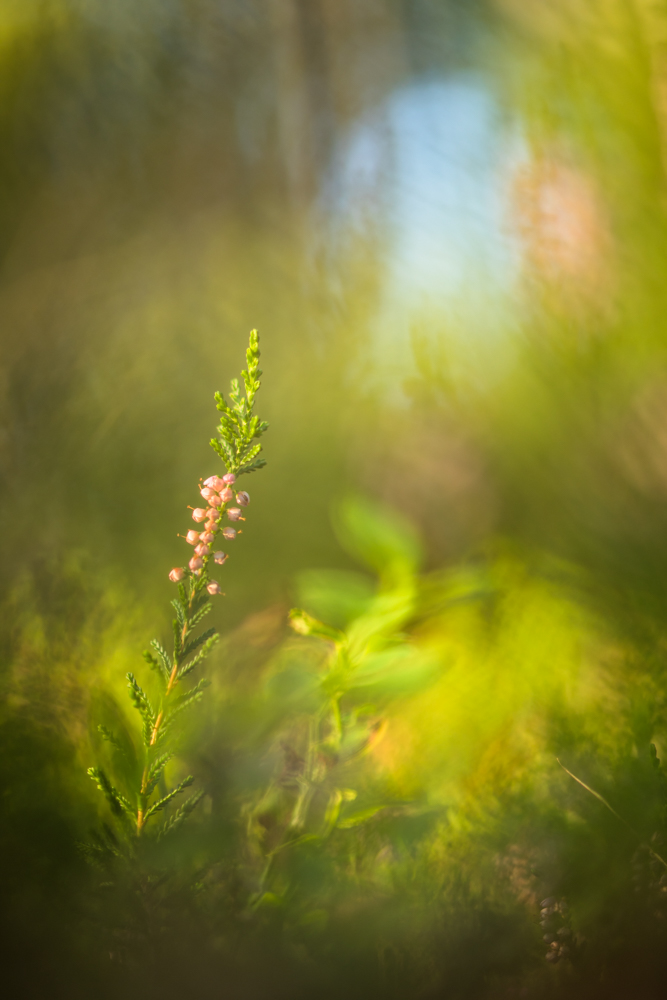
[88,330,268,853]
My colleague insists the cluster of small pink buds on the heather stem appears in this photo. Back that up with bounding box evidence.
[169,472,250,594]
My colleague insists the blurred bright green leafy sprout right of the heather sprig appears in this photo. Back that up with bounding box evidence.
[247,498,435,907]
